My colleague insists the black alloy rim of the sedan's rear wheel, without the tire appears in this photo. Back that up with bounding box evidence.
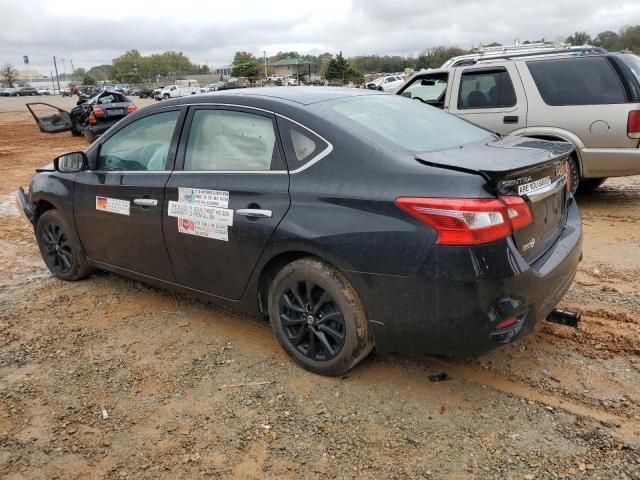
[279,280,346,361]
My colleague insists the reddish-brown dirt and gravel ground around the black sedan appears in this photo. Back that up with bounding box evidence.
[0,98,640,480]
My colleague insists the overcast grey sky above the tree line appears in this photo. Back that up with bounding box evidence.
[0,0,640,74]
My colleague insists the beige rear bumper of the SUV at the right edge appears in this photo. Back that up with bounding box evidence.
[580,148,640,178]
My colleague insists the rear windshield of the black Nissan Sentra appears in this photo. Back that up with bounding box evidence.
[322,95,493,152]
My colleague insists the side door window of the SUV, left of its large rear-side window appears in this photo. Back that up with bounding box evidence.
[458,69,516,110]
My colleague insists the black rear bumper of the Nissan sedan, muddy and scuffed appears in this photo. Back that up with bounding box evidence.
[345,200,582,356]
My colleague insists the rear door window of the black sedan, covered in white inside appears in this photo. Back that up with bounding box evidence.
[184,110,282,171]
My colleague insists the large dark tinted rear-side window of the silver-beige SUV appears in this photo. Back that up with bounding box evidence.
[527,57,627,106]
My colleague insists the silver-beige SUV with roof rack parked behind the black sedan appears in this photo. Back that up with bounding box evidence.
[398,47,640,192]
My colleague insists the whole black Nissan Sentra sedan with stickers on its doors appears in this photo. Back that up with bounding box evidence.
[18,87,582,375]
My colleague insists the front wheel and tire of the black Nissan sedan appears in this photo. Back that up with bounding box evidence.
[36,210,91,282]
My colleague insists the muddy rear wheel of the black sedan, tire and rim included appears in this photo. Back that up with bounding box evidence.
[268,257,373,376]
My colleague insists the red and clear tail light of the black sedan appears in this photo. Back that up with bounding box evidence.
[395,196,533,245]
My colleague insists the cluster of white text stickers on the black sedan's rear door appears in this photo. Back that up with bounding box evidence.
[168,188,233,242]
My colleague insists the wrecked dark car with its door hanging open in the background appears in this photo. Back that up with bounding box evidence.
[27,91,137,142]
